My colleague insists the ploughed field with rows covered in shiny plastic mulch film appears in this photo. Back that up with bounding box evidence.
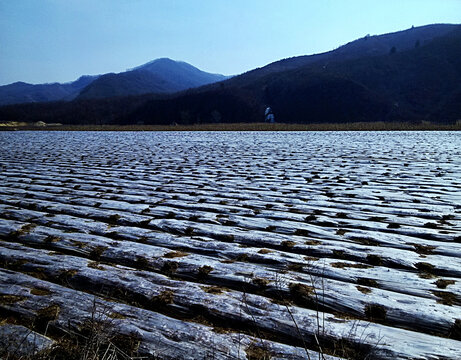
[0,131,461,360]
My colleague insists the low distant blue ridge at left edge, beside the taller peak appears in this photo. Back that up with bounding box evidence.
[0,76,97,105]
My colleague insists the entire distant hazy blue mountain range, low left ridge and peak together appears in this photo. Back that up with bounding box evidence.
[0,58,228,105]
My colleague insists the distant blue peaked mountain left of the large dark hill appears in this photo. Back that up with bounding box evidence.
[78,58,227,99]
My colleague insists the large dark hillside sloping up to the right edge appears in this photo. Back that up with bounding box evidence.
[121,25,461,124]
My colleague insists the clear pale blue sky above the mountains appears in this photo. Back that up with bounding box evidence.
[0,0,461,84]
